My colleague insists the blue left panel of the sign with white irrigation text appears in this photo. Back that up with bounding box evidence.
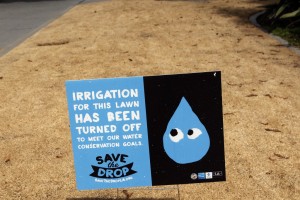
[66,77,152,190]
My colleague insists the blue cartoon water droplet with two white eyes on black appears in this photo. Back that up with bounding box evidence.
[163,97,210,164]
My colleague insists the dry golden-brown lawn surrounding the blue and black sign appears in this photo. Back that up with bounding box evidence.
[0,0,300,200]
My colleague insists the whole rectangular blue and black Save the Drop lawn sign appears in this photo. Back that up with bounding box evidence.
[66,71,225,190]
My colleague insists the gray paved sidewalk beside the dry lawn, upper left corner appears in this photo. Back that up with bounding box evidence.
[0,0,105,56]
